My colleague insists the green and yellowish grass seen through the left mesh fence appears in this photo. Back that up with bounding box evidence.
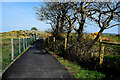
[0,38,34,70]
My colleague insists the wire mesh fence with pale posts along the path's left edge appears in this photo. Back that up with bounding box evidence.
[2,36,38,70]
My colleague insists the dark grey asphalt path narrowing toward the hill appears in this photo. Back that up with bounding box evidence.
[2,40,74,80]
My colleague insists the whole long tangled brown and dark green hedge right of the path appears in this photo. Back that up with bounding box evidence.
[44,35,120,77]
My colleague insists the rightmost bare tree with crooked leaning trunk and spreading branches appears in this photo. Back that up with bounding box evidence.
[87,2,120,43]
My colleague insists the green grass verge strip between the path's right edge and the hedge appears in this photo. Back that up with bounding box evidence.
[49,51,105,80]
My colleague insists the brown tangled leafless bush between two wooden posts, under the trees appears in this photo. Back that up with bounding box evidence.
[66,38,99,70]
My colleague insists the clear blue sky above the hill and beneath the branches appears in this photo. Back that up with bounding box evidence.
[0,2,118,33]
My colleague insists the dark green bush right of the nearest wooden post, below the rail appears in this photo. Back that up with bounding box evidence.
[100,55,120,76]
